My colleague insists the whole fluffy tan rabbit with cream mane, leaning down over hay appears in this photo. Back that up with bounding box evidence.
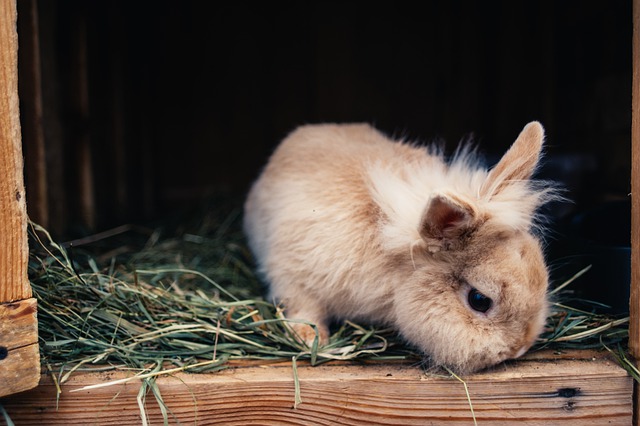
[243,121,556,374]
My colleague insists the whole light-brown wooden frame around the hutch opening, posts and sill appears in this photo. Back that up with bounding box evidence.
[0,0,640,425]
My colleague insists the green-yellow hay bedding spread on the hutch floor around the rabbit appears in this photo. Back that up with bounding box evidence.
[29,201,629,383]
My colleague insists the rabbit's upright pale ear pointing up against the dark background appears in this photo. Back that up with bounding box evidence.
[480,121,544,197]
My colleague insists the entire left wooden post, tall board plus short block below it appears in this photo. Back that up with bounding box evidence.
[0,0,40,396]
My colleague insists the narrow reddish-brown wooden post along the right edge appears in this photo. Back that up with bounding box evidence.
[629,0,640,425]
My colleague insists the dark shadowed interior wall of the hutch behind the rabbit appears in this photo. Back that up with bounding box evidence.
[18,0,632,236]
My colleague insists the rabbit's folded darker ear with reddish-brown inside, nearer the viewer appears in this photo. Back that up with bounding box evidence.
[420,195,476,252]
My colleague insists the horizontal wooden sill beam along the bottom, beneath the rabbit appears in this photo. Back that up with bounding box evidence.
[0,352,633,426]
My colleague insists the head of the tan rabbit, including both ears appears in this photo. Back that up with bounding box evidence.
[395,123,552,373]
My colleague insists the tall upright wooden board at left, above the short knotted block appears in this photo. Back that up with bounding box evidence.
[0,0,31,302]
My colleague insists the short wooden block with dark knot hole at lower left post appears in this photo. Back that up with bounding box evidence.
[0,298,40,396]
